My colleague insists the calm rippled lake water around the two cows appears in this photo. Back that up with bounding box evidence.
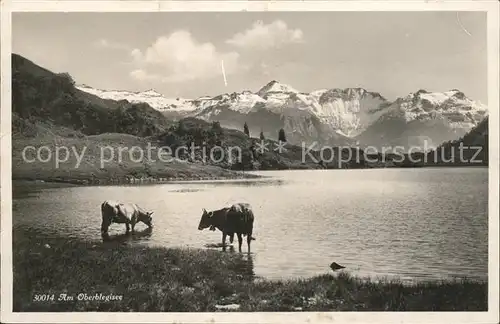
[13,168,488,280]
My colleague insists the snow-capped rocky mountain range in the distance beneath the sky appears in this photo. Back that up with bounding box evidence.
[76,81,488,150]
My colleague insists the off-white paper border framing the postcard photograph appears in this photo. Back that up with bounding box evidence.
[0,0,500,323]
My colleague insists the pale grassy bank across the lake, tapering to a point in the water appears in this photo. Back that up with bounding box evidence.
[12,133,258,184]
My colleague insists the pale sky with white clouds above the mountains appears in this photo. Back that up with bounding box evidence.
[12,12,487,104]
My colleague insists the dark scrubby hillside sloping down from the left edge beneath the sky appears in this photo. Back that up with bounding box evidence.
[12,54,175,137]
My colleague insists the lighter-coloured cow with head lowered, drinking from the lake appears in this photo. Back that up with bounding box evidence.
[101,201,153,235]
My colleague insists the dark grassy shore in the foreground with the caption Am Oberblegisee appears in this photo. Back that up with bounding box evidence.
[13,229,487,312]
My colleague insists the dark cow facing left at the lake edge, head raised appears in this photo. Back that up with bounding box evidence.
[198,203,255,253]
